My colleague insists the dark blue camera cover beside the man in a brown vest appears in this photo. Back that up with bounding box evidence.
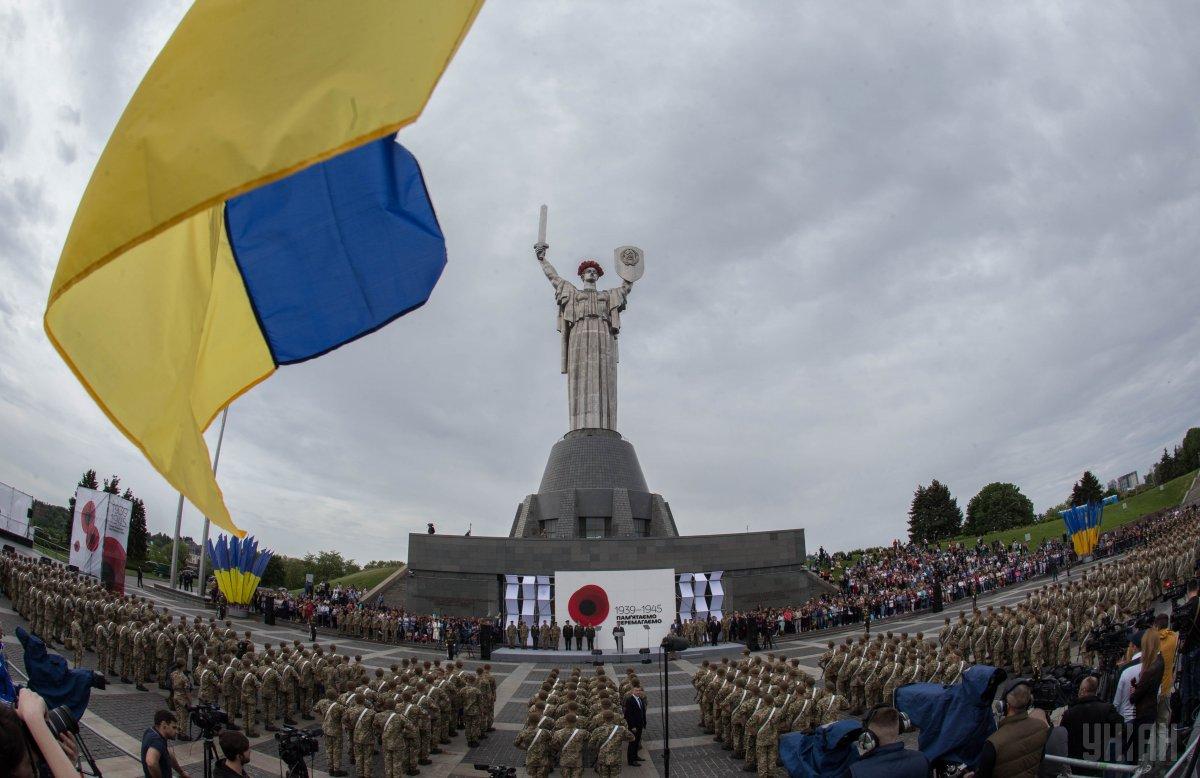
[895,665,1007,767]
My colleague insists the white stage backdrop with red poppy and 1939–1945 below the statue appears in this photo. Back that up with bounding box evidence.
[554,568,676,653]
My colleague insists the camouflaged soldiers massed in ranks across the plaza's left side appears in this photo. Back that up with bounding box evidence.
[0,555,497,778]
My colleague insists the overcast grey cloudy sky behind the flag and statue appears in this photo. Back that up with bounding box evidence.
[0,0,1200,561]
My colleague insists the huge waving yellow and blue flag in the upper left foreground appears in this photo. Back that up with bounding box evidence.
[44,0,482,535]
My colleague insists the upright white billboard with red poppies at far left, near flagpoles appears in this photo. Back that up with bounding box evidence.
[70,486,133,594]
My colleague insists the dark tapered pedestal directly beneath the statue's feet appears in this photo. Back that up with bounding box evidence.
[509,430,679,539]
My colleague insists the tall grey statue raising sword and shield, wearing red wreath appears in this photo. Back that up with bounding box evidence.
[534,205,646,432]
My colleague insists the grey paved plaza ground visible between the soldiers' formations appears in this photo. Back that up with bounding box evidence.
[0,559,1094,778]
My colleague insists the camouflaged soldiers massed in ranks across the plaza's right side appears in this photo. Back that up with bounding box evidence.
[692,511,1200,776]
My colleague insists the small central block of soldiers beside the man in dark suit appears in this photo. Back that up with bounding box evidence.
[516,668,642,778]
